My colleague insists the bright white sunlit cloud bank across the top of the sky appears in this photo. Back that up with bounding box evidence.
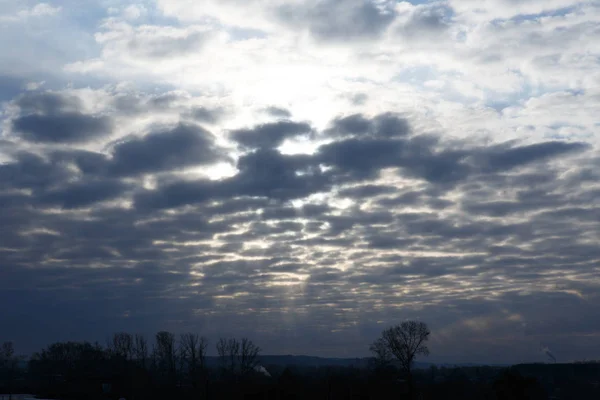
[54,0,600,147]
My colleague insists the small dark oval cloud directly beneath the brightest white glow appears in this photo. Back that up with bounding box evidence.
[231,121,312,148]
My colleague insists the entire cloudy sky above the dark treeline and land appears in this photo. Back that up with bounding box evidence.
[0,0,600,363]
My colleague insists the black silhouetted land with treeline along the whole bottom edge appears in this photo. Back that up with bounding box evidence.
[0,332,600,400]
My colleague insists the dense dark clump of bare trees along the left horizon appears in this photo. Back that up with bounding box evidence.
[0,331,260,398]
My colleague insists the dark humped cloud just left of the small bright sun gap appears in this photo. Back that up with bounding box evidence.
[109,124,227,176]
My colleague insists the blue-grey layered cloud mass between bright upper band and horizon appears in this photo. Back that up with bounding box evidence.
[0,104,600,362]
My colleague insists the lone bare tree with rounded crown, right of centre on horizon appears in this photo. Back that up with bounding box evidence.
[370,321,431,398]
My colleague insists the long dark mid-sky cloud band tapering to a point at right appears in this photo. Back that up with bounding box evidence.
[137,113,587,211]
